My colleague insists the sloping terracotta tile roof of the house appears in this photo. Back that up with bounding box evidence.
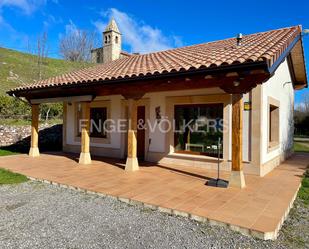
[11,26,301,92]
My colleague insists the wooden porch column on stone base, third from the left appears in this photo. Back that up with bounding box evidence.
[125,99,139,171]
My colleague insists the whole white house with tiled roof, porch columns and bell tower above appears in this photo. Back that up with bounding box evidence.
[8,20,307,188]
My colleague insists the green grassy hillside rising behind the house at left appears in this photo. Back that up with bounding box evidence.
[0,47,90,95]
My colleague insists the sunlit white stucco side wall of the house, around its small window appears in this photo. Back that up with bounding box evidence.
[262,60,294,163]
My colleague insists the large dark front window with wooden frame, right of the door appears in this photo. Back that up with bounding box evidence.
[174,104,223,157]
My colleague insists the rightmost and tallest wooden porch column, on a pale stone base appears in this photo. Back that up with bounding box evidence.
[229,94,246,188]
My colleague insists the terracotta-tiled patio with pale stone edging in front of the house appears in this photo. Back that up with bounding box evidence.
[0,154,309,239]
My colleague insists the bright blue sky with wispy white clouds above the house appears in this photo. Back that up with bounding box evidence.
[0,0,309,103]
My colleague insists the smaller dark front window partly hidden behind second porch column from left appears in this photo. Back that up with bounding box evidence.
[77,104,107,138]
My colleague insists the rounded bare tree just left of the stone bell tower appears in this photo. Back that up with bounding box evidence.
[59,29,95,61]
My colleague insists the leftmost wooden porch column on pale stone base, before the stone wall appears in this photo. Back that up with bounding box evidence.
[29,104,40,157]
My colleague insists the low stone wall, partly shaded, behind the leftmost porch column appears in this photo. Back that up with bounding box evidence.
[0,124,62,151]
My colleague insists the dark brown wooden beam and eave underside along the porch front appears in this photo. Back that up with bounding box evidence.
[18,70,270,101]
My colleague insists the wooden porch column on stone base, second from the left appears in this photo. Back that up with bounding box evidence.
[78,102,91,164]
